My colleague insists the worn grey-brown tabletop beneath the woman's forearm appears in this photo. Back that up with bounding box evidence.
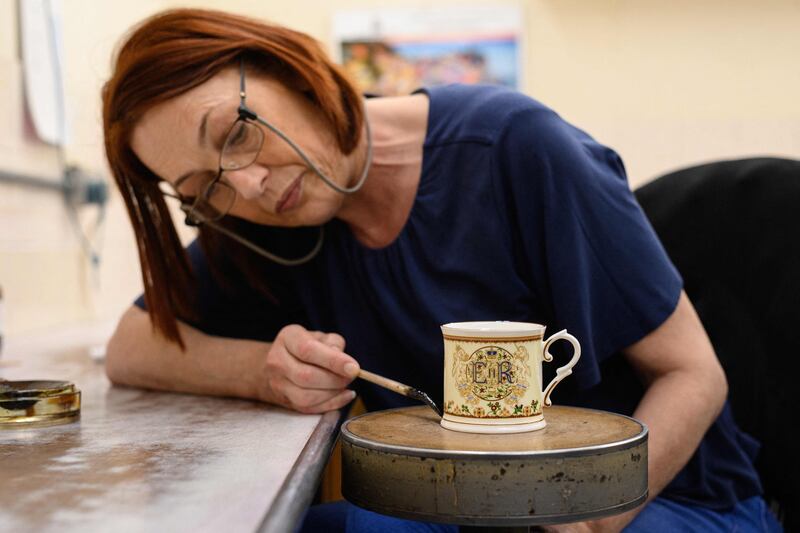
[0,323,338,533]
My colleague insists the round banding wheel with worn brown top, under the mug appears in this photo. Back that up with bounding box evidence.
[341,406,647,527]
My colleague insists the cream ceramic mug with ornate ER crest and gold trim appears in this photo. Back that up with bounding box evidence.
[441,321,581,433]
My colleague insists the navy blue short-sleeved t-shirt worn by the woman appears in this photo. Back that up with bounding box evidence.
[138,85,761,508]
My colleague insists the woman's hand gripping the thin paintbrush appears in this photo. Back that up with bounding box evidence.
[259,324,359,413]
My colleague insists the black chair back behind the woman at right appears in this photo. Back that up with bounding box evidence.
[636,158,800,531]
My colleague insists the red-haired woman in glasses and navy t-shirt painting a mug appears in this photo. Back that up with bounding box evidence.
[103,10,780,531]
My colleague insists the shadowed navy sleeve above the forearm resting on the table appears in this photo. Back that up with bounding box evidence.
[134,240,290,341]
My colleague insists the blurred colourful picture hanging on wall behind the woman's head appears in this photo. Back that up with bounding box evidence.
[333,6,522,95]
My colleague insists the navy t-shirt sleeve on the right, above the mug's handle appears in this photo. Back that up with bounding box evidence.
[499,108,683,387]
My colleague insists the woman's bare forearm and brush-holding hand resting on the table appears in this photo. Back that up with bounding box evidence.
[106,306,358,413]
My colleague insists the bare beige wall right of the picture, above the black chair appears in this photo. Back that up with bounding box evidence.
[528,0,800,185]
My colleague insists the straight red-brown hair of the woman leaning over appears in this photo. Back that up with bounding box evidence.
[103,9,364,347]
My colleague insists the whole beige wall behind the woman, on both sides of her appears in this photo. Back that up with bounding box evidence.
[0,0,800,335]
